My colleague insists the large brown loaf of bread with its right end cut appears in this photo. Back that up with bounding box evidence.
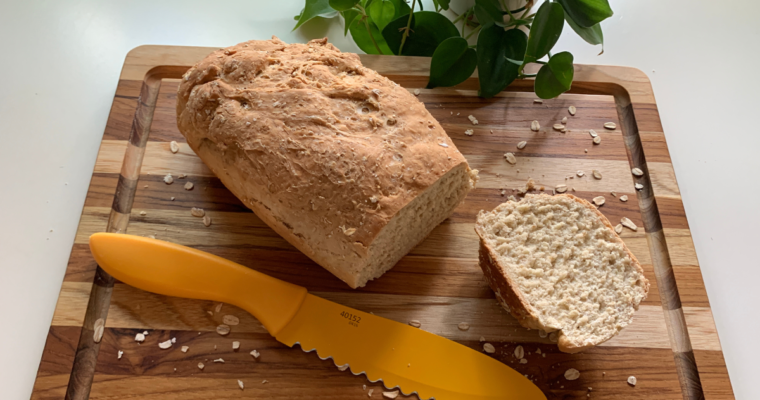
[177,38,477,288]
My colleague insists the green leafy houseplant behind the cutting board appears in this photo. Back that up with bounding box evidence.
[294,0,612,99]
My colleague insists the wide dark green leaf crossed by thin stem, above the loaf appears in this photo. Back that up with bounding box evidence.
[383,11,459,57]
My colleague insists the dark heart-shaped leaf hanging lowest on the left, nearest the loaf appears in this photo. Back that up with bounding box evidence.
[427,37,478,89]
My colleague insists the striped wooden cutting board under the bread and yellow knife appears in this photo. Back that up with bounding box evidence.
[32,46,733,399]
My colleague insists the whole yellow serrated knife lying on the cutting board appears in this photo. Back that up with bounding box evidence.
[90,233,546,400]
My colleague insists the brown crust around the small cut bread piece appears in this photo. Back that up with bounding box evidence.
[475,194,649,353]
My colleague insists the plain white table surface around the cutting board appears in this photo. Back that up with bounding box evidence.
[0,0,760,399]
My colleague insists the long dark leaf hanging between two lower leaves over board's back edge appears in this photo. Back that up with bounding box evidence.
[478,25,528,98]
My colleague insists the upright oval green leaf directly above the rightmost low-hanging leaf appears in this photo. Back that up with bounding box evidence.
[524,1,565,64]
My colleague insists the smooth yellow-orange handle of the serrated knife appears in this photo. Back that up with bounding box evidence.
[90,233,306,336]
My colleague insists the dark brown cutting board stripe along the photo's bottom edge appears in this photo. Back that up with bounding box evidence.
[86,327,680,399]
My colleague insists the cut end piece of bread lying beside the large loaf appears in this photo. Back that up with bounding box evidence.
[475,194,649,353]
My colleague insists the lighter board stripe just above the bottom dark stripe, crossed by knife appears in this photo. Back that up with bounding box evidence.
[53,282,720,350]
